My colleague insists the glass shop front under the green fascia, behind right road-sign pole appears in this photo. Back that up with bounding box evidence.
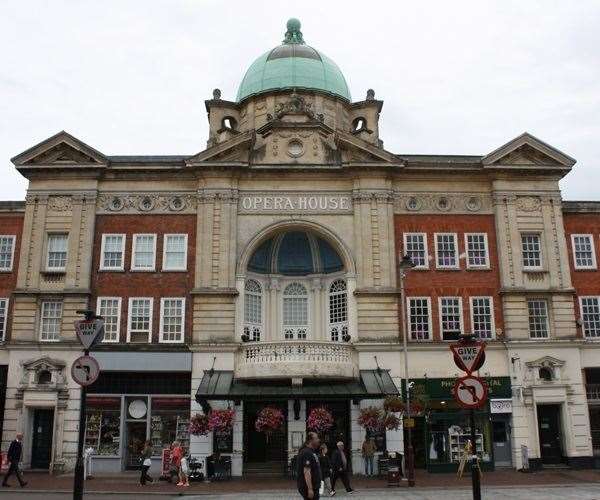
[426,410,493,465]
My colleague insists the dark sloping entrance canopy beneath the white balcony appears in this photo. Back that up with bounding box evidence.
[196,370,399,405]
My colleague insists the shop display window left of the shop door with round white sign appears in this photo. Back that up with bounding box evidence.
[85,398,121,456]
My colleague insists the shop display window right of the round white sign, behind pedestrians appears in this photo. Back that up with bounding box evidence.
[150,398,190,456]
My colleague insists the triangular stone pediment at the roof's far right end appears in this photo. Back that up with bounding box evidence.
[481,132,575,169]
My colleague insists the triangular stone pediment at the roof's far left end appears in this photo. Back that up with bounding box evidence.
[11,131,108,167]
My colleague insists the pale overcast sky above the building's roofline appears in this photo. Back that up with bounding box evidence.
[0,0,600,200]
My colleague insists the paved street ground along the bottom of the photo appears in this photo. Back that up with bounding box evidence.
[0,469,600,500]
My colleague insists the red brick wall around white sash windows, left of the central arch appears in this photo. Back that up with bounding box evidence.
[91,215,196,343]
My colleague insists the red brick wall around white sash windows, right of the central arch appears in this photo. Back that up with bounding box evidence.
[395,215,503,340]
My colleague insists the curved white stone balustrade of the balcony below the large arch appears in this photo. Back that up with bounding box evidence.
[236,340,358,378]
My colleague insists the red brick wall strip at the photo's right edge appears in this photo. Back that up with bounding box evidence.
[564,213,600,336]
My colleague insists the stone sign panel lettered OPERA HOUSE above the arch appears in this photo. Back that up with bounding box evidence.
[238,193,352,213]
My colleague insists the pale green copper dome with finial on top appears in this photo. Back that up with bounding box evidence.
[237,19,351,102]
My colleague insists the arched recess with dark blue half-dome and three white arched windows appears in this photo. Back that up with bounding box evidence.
[240,230,350,342]
